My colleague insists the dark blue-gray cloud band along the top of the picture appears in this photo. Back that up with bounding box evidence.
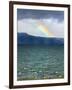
[17,9,64,21]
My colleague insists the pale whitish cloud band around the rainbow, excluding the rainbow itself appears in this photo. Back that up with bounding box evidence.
[18,18,64,38]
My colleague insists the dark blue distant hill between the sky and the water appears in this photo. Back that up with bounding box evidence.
[17,33,64,45]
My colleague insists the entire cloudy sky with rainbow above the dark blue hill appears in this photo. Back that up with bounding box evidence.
[17,9,64,38]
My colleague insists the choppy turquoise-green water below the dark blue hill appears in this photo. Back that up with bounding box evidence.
[17,46,64,80]
